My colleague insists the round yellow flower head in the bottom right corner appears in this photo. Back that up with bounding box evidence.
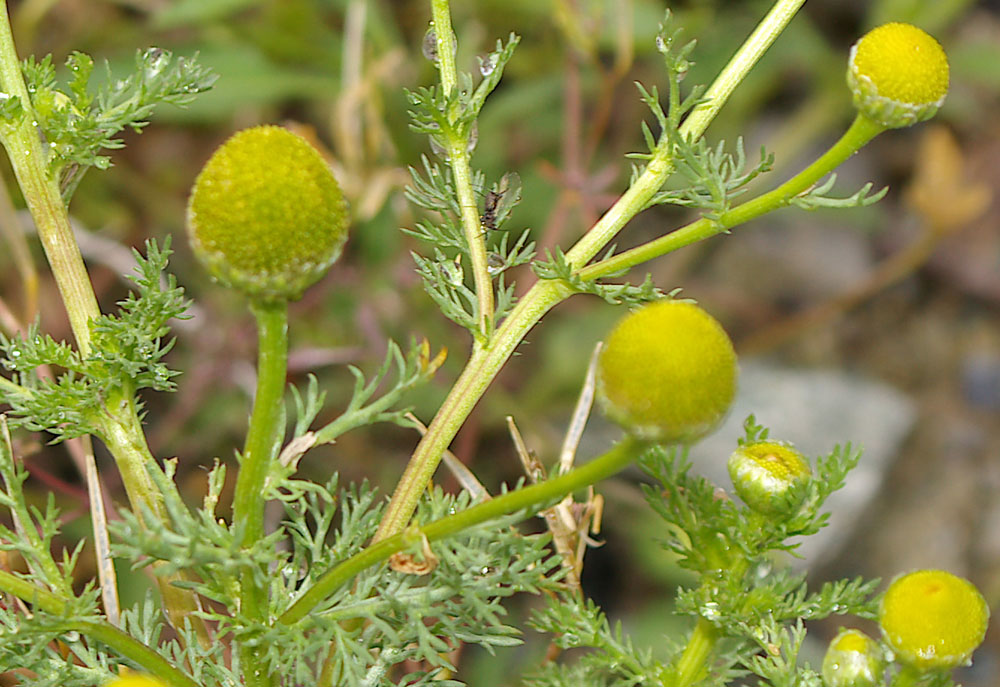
[879,570,990,670]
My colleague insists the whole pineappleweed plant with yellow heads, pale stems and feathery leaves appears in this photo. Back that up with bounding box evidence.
[0,0,988,687]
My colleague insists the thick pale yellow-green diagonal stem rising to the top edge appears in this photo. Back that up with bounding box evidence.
[375,0,803,541]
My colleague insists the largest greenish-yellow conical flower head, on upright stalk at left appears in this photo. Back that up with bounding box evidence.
[188,126,348,300]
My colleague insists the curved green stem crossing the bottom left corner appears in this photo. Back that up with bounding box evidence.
[0,571,199,687]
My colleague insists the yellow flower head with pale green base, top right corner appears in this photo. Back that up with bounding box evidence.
[847,22,948,129]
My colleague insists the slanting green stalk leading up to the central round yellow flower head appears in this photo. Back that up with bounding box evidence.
[286,438,647,625]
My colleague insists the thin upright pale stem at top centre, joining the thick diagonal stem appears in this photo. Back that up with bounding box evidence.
[431,0,493,343]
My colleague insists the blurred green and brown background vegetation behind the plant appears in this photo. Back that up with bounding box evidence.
[0,0,1000,685]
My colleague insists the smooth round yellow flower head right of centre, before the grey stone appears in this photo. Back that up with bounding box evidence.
[597,300,737,443]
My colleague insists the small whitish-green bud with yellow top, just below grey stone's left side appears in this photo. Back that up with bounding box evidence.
[729,441,812,515]
